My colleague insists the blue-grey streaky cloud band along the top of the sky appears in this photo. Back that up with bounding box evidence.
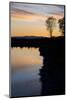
[11,3,64,15]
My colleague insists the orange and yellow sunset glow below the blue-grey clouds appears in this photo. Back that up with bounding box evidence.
[11,4,64,37]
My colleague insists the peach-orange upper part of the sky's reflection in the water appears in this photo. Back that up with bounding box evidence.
[11,47,43,68]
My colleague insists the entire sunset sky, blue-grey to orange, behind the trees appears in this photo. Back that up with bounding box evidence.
[10,2,64,37]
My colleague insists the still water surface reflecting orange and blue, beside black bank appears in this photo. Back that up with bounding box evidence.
[11,47,43,96]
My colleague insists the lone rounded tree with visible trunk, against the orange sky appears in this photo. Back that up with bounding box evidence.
[46,17,56,37]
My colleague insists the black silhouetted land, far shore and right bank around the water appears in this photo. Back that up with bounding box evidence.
[11,37,65,97]
